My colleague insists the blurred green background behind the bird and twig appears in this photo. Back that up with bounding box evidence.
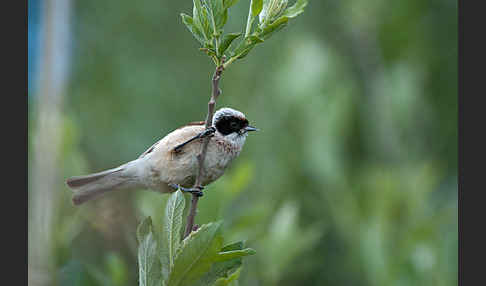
[28,0,458,286]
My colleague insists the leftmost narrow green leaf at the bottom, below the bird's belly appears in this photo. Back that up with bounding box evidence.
[137,217,162,286]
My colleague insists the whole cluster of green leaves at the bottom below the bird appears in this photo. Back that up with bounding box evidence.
[137,191,255,286]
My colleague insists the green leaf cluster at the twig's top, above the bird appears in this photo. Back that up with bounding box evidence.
[181,0,307,67]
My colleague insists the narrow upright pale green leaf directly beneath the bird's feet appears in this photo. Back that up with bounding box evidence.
[161,190,186,275]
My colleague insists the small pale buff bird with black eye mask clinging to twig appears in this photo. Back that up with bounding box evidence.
[66,107,258,205]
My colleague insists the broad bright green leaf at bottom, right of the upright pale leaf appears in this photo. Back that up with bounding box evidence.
[167,222,223,286]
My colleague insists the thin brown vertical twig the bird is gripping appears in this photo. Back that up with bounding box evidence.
[184,56,225,238]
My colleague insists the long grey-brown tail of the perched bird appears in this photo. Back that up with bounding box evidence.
[66,161,141,205]
